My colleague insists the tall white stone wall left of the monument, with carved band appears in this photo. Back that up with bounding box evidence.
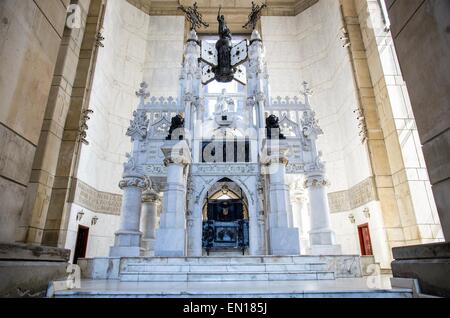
[65,1,184,257]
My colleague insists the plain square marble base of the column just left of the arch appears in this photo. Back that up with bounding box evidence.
[155,228,186,257]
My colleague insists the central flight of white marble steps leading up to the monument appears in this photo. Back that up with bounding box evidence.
[119,256,335,282]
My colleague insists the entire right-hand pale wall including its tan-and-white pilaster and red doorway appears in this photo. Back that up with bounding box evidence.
[262,0,442,267]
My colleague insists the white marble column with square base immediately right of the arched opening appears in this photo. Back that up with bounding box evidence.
[262,139,300,255]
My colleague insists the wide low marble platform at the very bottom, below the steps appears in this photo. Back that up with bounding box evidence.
[53,276,413,299]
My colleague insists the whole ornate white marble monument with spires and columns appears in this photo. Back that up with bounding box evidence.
[110,30,340,257]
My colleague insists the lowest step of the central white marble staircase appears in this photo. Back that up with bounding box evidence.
[120,271,335,282]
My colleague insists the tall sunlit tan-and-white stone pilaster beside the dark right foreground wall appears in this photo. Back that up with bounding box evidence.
[355,0,443,244]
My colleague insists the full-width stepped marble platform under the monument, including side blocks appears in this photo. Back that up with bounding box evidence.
[78,255,377,282]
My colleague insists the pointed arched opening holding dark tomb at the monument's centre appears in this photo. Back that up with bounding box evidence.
[202,178,249,255]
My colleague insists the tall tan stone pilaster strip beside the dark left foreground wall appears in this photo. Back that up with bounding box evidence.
[16,0,90,244]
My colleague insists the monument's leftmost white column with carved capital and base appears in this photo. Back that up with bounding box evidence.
[109,177,148,257]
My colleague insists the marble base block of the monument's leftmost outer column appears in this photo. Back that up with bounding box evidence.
[109,231,142,257]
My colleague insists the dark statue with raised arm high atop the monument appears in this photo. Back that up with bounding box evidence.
[214,7,235,83]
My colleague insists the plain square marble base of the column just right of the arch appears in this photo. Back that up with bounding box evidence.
[269,228,300,256]
